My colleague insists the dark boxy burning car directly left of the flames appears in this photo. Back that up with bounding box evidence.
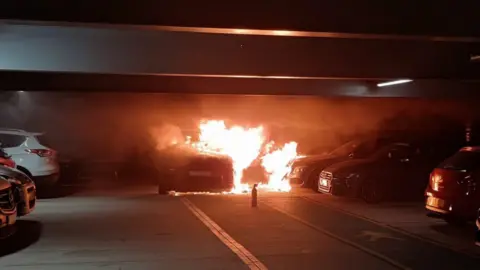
[153,146,233,194]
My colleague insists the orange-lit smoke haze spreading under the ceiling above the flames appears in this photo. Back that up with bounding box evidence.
[0,92,472,160]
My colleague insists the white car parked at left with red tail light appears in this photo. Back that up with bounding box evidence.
[0,128,60,186]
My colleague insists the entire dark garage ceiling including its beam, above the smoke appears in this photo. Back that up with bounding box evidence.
[0,0,480,97]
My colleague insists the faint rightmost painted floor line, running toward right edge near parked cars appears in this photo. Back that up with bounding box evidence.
[300,196,480,259]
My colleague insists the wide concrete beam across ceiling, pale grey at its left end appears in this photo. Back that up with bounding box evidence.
[0,22,480,80]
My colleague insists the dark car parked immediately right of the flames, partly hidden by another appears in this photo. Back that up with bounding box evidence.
[287,138,398,191]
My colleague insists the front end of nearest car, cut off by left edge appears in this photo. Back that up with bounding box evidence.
[0,177,17,235]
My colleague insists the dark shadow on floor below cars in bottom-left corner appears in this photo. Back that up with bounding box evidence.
[0,220,42,257]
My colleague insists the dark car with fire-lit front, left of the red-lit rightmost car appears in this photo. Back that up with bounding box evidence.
[318,143,450,203]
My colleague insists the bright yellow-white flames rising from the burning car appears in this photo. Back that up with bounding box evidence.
[190,120,297,193]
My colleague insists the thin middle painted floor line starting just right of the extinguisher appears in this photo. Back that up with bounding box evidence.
[264,201,411,270]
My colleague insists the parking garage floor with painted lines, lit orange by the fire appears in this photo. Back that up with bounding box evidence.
[0,187,480,270]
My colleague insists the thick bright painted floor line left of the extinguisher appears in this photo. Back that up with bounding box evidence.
[181,197,268,270]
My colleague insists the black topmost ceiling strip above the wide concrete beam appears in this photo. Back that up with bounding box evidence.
[0,0,480,37]
